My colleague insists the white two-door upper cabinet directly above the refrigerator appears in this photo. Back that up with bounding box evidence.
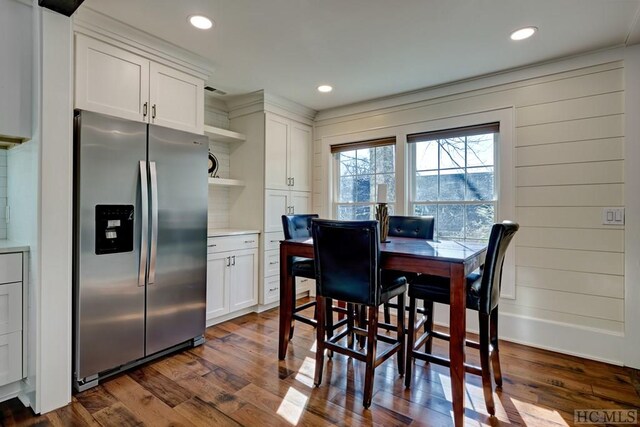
[75,35,204,134]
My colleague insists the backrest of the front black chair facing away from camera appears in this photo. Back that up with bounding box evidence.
[311,219,380,306]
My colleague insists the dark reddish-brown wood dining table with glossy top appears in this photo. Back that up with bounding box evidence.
[278,237,487,426]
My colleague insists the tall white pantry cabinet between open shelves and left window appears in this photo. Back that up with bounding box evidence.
[229,92,315,305]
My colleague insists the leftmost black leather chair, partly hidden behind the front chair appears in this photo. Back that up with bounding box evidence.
[282,214,318,339]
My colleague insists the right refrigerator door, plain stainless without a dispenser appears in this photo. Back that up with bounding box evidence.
[146,125,208,355]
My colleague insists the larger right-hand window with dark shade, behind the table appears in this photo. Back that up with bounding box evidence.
[407,123,498,241]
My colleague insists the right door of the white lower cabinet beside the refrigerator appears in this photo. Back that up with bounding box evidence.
[229,249,258,311]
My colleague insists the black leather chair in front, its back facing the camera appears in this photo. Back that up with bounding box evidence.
[312,219,406,408]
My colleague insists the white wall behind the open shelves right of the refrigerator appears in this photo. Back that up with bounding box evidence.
[205,109,230,229]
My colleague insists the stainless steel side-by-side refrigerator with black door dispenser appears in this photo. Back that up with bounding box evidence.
[73,111,208,390]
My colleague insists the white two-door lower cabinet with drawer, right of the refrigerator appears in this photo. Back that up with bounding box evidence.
[207,234,258,321]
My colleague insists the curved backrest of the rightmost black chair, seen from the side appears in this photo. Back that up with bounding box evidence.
[478,221,520,314]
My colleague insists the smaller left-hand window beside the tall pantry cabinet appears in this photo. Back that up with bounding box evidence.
[331,138,396,220]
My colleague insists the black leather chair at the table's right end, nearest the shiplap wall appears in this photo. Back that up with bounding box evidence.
[405,221,519,415]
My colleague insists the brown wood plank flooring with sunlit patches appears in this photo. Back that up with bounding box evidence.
[0,300,640,427]
